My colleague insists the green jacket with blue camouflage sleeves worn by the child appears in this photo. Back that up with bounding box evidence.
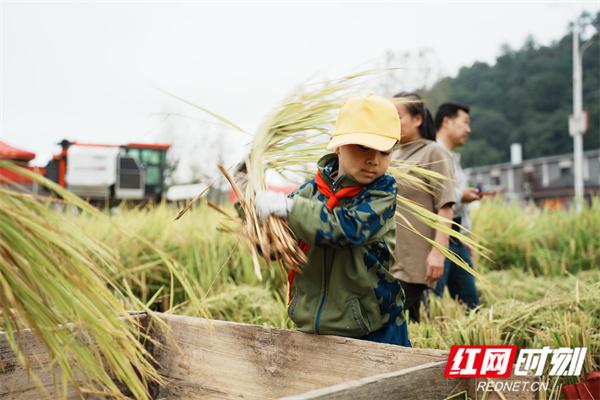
[288,154,404,337]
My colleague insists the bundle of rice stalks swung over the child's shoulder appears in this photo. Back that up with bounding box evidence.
[173,71,488,277]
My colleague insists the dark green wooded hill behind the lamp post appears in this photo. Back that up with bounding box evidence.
[423,12,600,166]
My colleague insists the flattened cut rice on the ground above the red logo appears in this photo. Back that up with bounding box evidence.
[409,269,600,382]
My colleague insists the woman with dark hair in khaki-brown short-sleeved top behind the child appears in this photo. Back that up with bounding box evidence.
[391,93,454,322]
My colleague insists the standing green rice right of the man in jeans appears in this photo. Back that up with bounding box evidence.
[473,199,600,275]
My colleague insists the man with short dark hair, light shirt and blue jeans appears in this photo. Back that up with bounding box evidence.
[435,103,482,309]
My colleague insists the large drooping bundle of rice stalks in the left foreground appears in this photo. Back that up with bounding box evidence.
[0,161,210,399]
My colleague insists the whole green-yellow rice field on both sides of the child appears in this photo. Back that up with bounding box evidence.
[0,193,600,398]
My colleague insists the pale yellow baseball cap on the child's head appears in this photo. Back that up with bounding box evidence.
[327,94,400,151]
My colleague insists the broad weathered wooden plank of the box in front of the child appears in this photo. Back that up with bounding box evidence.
[155,315,448,399]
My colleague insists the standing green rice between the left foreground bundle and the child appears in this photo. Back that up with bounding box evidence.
[76,201,284,316]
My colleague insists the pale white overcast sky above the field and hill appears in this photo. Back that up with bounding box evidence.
[0,1,600,179]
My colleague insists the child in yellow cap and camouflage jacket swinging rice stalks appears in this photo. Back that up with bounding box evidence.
[256,95,410,346]
